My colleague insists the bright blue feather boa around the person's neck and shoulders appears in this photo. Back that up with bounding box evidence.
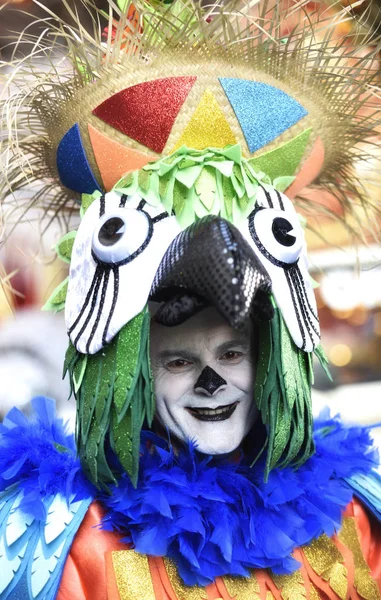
[0,398,377,585]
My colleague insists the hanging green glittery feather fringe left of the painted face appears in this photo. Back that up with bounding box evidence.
[64,308,155,489]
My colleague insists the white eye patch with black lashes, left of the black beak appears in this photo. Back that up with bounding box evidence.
[65,192,180,354]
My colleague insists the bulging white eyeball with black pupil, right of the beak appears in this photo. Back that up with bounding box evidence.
[249,207,304,264]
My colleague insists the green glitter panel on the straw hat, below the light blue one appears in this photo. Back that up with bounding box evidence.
[247,127,312,181]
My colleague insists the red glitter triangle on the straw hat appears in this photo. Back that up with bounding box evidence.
[93,77,197,153]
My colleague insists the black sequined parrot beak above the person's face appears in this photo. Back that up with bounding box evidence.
[150,215,273,329]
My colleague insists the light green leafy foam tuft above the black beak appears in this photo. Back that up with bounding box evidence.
[114,144,274,228]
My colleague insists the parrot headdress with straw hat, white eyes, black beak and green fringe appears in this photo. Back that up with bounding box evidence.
[2,0,377,485]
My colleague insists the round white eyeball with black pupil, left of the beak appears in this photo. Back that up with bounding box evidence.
[92,208,153,265]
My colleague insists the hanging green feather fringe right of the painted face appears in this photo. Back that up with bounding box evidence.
[254,308,314,479]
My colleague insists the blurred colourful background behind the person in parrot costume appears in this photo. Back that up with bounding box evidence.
[0,0,381,441]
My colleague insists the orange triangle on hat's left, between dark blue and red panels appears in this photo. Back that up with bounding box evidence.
[89,125,155,192]
